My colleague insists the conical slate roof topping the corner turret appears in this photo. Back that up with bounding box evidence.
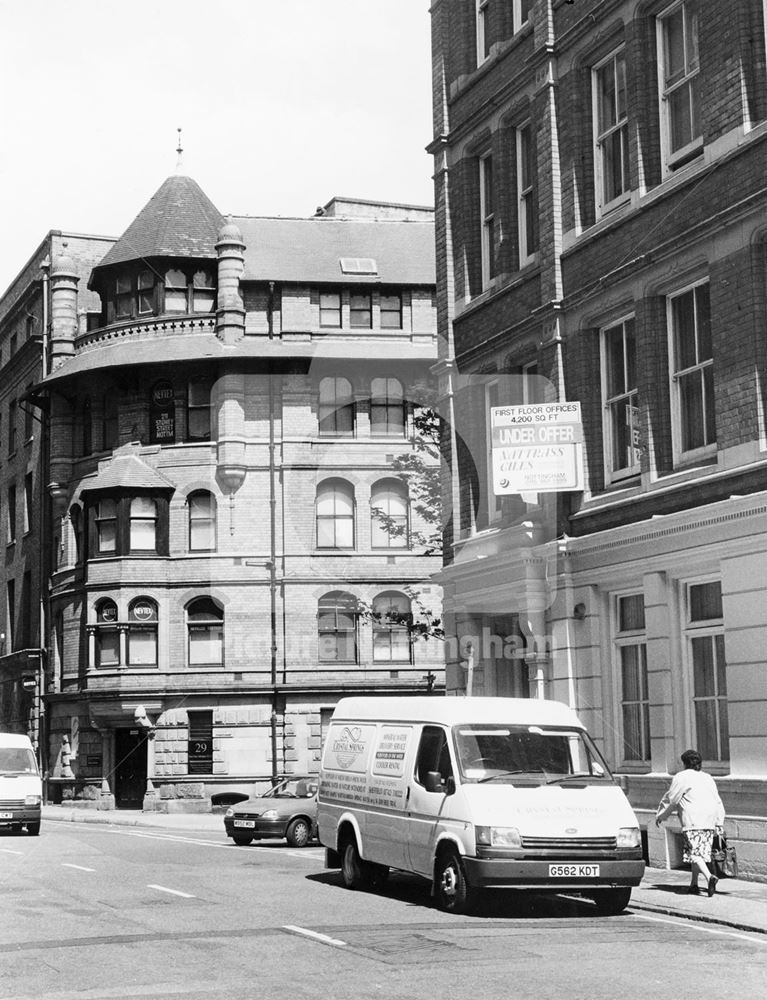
[96,174,224,270]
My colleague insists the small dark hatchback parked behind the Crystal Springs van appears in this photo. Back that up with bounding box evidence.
[224,775,317,847]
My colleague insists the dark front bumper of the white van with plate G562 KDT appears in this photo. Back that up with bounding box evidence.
[463,858,645,892]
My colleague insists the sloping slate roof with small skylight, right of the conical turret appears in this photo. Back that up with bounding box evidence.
[233,216,436,285]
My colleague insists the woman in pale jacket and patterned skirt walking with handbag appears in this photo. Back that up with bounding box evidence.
[655,750,724,896]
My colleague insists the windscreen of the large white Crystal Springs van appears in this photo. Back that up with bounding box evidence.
[453,725,613,785]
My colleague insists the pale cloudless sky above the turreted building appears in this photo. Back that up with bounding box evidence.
[0,0,434,294]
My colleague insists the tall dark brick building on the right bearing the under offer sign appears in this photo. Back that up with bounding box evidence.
[431,0,767,878]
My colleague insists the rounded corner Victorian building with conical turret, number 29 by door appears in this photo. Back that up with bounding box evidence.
[4,174,444,810]
